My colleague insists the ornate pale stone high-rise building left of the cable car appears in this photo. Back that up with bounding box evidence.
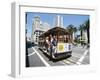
[31,16,50,44]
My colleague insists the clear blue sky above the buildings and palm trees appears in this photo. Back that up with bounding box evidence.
[26,12,89,37]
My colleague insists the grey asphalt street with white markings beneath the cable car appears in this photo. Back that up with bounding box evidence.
[26,44,90,67]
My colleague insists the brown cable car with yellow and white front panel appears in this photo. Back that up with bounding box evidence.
[38,27,72,59]
